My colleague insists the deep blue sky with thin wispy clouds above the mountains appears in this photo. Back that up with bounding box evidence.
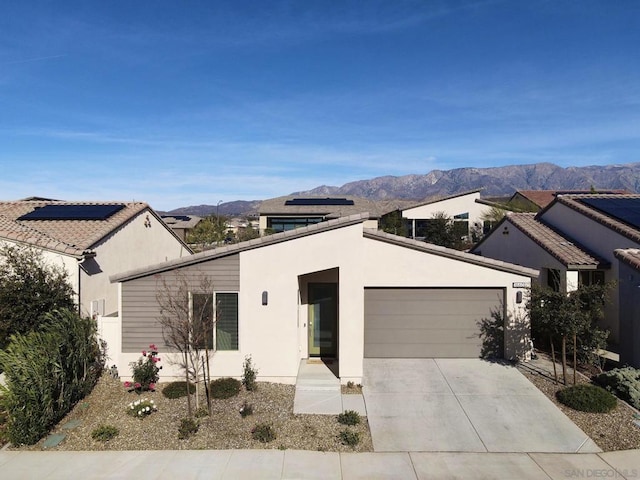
[0,0,640,210]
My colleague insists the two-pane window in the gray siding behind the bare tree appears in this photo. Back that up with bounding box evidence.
[191,292,238,350]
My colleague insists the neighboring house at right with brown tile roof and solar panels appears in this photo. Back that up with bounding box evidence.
[471,193,640,366]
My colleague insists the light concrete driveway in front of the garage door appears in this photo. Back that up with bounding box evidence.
[363,358,600,453]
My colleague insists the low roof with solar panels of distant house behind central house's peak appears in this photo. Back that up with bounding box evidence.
[260,195,409,218]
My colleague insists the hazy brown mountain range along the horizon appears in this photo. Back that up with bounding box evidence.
[169,163,640,216]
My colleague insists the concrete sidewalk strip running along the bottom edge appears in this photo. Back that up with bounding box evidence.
[0,450,640,480]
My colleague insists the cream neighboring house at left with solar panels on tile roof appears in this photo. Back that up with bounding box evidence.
[0,198,191,315]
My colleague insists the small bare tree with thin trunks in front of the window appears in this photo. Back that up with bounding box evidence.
[156,273,215,416]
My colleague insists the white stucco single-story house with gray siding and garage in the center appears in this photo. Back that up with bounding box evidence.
[111,214,538,383]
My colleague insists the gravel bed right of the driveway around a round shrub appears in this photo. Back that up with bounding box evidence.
[520,358,640,452]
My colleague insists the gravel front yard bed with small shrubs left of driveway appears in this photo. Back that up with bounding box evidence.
[12,375,373,452]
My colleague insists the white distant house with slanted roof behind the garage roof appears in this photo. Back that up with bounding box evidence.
[402,190,489,238]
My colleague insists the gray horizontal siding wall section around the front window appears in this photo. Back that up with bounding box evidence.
[121,254,240,353]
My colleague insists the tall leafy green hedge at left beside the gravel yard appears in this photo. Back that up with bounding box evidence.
[0,310,104,445]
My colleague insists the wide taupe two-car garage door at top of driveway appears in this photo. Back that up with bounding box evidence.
[364,288,504,358]
